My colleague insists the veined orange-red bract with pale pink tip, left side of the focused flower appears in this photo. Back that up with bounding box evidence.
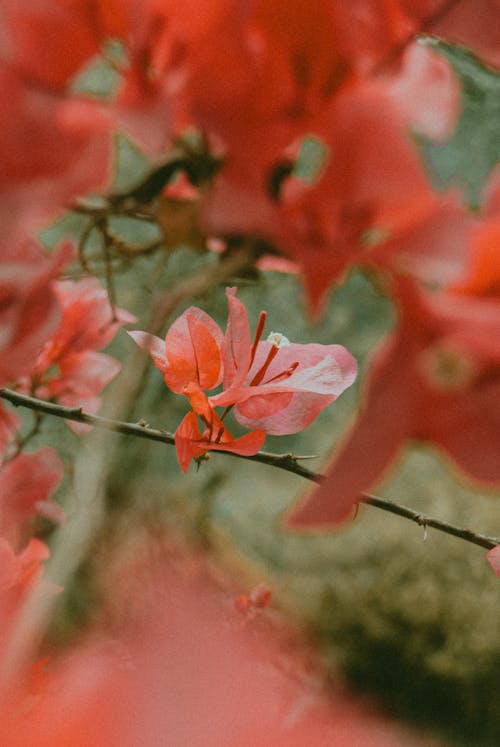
[129,306,224,394]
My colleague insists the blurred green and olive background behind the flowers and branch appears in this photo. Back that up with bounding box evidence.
[33,39,500,747]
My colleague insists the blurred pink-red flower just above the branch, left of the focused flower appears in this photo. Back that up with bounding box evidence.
[22,278,135,420]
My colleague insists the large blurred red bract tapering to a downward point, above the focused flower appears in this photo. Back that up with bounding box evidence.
[277,86,446,311]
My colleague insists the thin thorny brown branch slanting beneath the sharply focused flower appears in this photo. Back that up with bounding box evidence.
[0,389,500,550]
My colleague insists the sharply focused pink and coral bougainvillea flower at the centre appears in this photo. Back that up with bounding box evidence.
[129,288,356,471]
